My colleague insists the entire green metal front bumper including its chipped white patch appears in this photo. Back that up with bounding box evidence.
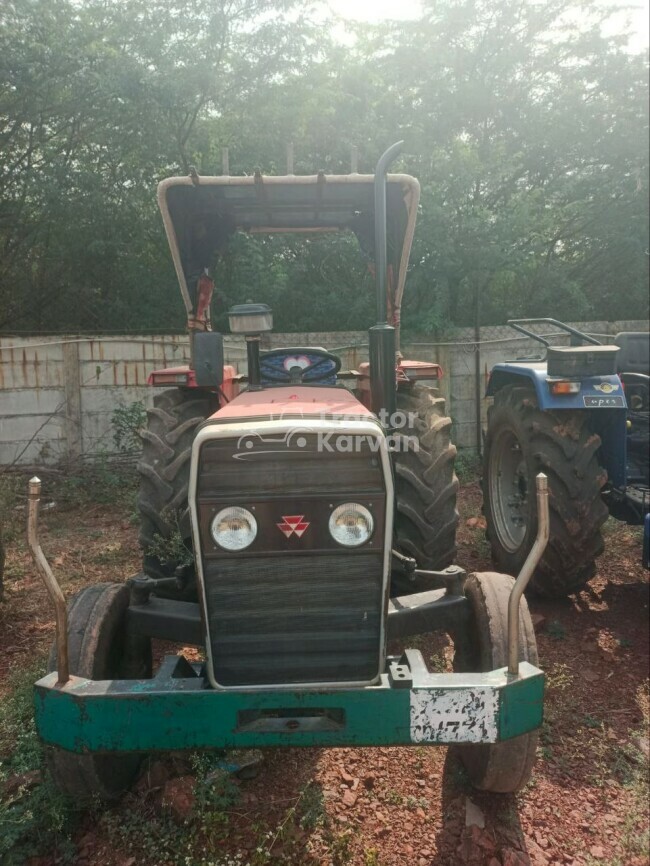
[35,650,544,753]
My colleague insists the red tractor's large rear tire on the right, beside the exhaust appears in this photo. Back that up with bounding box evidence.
[393,383,458,593]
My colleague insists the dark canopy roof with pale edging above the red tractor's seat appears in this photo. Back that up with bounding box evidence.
[158,172,420,322]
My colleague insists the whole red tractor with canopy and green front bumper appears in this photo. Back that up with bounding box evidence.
[29,146,548,800]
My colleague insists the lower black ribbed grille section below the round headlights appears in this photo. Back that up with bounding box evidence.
[204,553,383,687]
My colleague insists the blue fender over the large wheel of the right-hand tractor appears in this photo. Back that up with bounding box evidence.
[485,361,627,489]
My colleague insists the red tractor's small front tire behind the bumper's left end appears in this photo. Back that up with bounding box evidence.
[45,583,152,804]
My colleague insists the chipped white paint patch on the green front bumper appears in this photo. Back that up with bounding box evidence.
[411,687,499,743]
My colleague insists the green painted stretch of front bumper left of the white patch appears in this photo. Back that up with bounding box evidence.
[36,680,409,752]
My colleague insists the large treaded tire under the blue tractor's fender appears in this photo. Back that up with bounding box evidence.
[483,385,608,598]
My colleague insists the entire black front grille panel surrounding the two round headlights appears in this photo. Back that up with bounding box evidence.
[196,428,386,688]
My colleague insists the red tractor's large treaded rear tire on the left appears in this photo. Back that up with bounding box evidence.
[137,388,217,578]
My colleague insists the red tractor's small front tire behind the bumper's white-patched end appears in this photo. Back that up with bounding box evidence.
[454,572,539,794]
